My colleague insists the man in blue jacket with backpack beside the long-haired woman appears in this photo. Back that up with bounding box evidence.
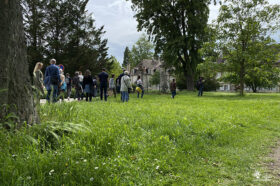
[44,59,61,103]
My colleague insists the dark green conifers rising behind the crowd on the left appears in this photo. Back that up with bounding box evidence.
[22,0,112,75]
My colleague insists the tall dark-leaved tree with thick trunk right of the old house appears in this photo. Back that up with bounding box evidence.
[132,0,211,90]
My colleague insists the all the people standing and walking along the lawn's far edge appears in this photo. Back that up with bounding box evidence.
[33,59,204,102]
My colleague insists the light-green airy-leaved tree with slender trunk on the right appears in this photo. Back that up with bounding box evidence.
[217,0,280,95]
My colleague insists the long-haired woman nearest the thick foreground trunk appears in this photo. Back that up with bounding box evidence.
[33,62,44,94]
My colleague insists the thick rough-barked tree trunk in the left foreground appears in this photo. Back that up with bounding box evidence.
[0,0,39,126]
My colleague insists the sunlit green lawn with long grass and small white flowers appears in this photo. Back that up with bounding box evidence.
[0,93,280,185]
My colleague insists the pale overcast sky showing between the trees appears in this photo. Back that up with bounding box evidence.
[87,0,280,63]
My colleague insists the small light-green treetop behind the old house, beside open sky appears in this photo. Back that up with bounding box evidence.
[127,34,154,67]
